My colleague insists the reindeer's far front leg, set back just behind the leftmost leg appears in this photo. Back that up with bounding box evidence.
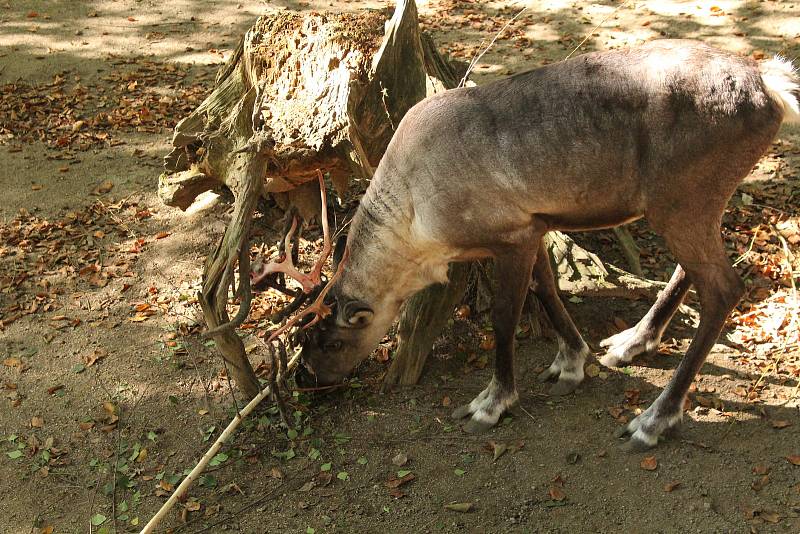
[533,241,589,395]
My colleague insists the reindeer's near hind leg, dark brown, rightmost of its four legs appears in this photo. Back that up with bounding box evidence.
[618,226,744,450]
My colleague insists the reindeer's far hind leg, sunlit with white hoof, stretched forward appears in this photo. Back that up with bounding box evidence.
[600,265,692,367]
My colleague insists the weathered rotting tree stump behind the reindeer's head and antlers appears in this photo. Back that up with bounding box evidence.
[159,0,466,397]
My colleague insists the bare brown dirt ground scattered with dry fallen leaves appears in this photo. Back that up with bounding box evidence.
[0,0,800,533]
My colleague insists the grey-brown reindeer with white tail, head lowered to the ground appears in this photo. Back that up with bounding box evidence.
[264,40,800,450]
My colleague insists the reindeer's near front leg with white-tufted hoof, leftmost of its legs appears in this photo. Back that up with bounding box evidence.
[453,245,538,433]
